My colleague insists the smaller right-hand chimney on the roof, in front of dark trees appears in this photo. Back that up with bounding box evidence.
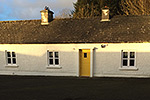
[101,6,110,21]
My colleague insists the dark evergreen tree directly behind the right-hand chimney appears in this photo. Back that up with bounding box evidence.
[74,0,120,18]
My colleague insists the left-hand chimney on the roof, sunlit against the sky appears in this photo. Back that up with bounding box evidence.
[40,6,54,25]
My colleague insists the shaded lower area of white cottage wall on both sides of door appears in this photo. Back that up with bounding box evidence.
[0,49,150,75]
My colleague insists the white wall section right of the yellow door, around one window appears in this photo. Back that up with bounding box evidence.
[94,43,150,77]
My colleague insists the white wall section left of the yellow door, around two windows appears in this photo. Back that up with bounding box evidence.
[0,44,77,76]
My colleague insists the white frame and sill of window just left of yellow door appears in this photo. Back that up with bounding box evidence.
[47,50,61,69]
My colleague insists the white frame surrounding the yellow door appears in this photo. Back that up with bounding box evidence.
[77,48,94,77]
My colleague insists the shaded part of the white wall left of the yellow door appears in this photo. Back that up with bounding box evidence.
[0,49,77,73]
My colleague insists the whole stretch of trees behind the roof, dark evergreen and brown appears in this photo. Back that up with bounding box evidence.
[73,0,150,18]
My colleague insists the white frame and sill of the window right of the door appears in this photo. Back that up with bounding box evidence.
[119,50,138,70]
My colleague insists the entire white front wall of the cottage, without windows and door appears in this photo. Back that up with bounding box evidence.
[0,43,150,77]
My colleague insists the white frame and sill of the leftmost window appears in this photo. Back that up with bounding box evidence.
[5,50,18,68]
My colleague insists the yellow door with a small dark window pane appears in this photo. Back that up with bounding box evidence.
[79,49,90,77]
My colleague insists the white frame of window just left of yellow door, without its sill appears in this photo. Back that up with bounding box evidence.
[47,50,60,67]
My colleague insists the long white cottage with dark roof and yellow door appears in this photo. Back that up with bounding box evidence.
[0,9,150,77]
